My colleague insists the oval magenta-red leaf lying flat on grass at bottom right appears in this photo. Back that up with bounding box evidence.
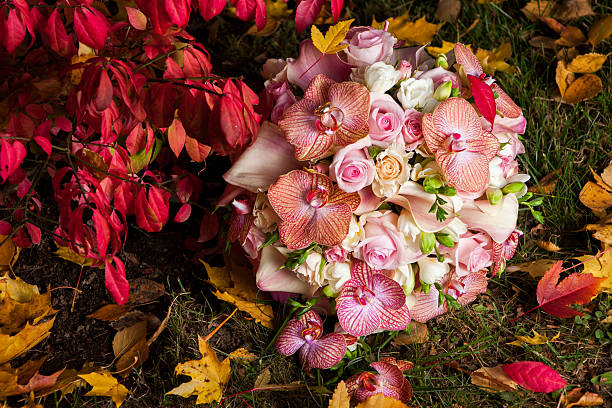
[502,361,567,393]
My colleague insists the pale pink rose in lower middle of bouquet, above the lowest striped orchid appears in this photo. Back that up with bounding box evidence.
[353,211,406,270]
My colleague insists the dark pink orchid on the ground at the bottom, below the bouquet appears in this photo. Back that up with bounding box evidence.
[346,357,412,402]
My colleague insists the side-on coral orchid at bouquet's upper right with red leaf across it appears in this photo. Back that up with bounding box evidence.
[455,43,522,125]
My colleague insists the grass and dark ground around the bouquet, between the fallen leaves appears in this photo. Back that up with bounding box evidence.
[47,0,612,408]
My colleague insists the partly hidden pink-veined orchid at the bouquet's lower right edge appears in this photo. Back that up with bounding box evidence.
[410,270,487,323]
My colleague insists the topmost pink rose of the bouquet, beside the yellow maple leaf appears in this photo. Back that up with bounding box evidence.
[343,27,396,67]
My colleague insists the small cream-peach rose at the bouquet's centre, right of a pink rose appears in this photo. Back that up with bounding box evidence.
[372,144,413,197]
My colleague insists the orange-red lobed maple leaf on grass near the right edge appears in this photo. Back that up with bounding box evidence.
[536,261,604,317]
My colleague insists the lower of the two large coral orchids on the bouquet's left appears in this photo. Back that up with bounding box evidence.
[268,170,360,249]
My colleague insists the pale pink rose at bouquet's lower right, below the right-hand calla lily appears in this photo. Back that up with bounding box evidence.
[450,233,493,276]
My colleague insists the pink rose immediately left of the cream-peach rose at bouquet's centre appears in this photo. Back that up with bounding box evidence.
[329,137,376,193]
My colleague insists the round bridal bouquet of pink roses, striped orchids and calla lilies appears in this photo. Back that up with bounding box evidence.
[220,20,530,399]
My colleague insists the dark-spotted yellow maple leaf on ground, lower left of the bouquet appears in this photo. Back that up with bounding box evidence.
[166,336,231,404]
